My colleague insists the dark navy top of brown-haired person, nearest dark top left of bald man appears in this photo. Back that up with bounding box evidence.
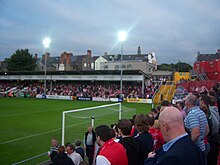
[135,132,153,165]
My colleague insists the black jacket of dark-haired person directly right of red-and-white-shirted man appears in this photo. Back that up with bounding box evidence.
[119,137,138,165]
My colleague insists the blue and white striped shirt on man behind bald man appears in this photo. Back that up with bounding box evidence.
[184,106,208,151]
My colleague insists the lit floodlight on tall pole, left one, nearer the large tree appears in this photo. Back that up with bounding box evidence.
[43,37,50,96]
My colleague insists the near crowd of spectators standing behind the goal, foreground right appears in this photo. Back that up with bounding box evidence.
[50,87,220,165]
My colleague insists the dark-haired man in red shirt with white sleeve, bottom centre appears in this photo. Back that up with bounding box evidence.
[95,125,128,165]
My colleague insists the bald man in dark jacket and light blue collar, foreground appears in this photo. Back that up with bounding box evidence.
[145,107,204,165]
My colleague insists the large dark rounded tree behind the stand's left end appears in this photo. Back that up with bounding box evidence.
[5,49,36,71]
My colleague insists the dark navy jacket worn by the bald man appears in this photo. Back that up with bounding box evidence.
[144,136,205,165]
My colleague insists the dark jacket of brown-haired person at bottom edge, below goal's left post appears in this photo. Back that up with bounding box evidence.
[53,153,74,165]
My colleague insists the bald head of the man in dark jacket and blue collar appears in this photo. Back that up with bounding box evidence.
[159,107,186,142]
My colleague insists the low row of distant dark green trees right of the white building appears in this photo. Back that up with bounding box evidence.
[157,62,192,72]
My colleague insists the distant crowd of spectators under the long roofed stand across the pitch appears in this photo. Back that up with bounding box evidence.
[0,81,159,98]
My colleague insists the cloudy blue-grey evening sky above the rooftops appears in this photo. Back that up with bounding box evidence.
[0,0,220,64]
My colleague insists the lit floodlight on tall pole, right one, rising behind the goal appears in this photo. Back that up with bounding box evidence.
[118,31,127,99]
